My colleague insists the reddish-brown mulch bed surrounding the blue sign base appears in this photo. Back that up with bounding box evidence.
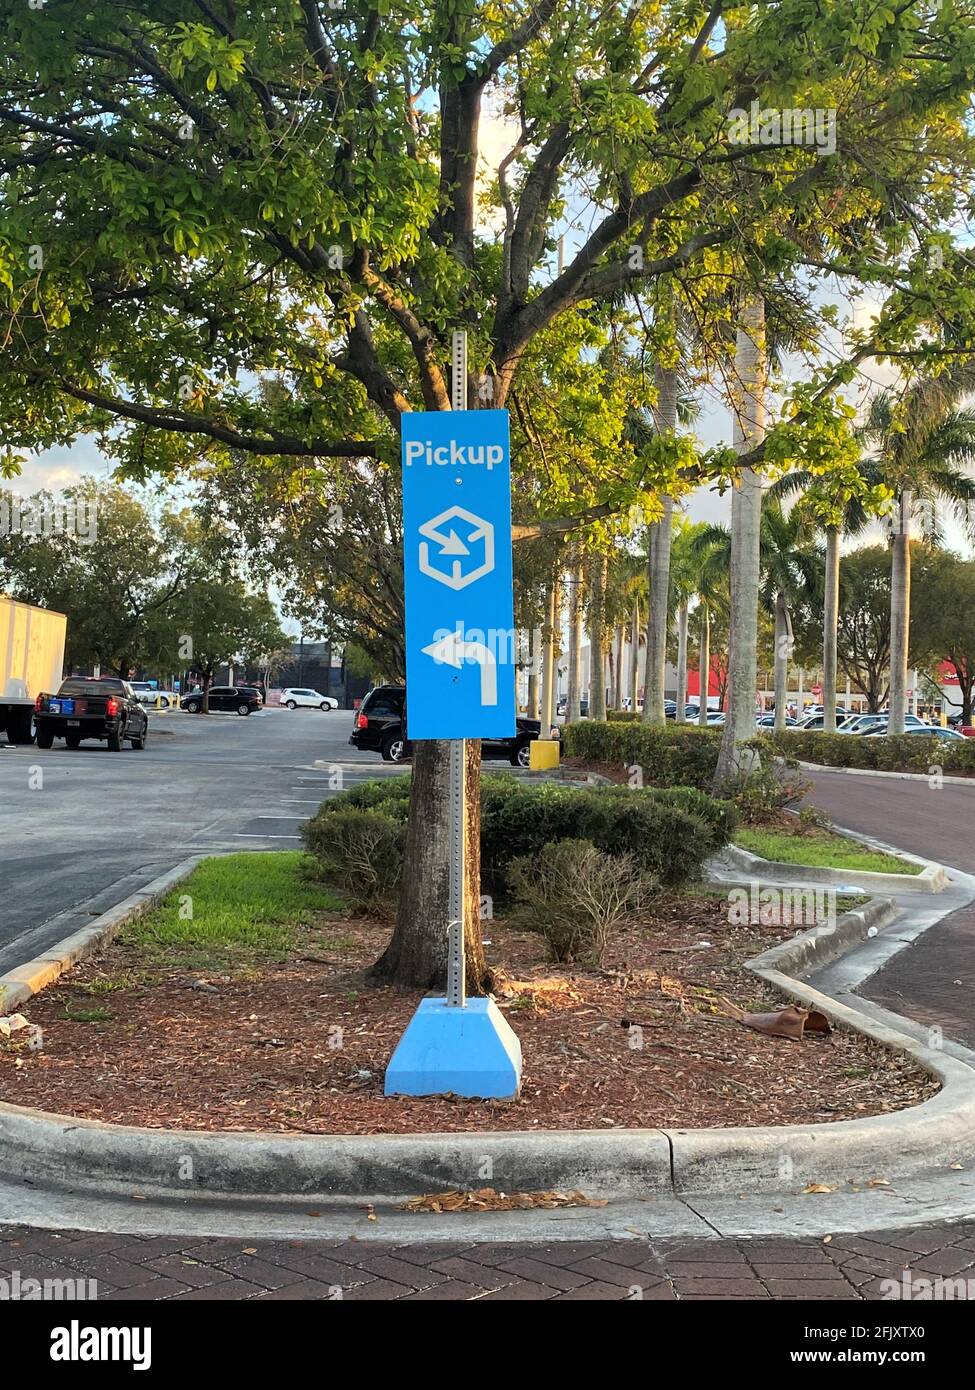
[0,894,937,1134]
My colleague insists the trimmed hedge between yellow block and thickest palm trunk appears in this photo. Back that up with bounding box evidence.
[562,720,722,791]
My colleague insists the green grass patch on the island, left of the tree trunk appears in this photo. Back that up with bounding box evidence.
[124,851,341,970]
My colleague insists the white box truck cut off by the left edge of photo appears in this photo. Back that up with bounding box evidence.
[0,594,68,744]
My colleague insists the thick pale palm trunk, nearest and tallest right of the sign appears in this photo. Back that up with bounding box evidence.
[715,299,765,787]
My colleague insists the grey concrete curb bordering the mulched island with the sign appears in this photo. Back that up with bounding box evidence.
[0,855,975,1205]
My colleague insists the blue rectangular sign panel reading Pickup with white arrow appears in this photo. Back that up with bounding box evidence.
[403,410,516,739]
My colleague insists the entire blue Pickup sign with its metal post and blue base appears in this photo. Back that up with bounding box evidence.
[384,332,522,1099]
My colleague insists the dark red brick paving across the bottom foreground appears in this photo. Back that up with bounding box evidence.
[0,1222,975,1301]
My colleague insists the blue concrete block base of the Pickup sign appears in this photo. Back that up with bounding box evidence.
[385,998,522,1101]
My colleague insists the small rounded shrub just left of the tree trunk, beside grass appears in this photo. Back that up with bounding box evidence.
[302,808,406,912]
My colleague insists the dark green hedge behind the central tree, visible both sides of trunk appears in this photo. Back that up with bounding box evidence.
[302,774,736,898]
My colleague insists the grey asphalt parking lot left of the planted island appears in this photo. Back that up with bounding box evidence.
[0,709,391,972]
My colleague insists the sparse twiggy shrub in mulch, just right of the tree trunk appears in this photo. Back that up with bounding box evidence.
[508,840,655,965]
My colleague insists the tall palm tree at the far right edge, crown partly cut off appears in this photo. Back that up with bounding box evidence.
[860,378,975,734]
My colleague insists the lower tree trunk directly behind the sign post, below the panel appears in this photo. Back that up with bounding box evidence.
[371,738,487,994]
